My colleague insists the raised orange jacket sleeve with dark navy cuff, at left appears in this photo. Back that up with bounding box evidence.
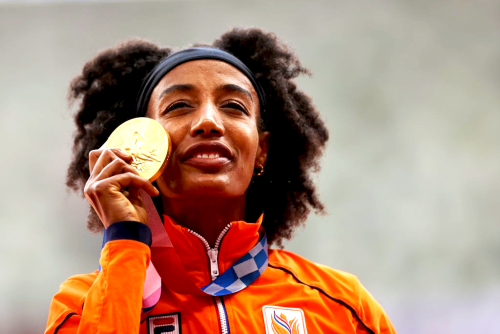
[45,222,151,334]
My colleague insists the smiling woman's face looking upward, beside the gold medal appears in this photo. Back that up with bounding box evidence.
[147,60,269,199]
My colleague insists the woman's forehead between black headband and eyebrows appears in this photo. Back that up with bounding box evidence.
[152,59,257,98]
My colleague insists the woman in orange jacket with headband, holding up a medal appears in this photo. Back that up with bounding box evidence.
[46,29,395,334]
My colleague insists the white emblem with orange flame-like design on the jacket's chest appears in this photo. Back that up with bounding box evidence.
[262,305,307,334]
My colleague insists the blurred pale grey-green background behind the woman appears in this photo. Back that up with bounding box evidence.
[0,0,500,334]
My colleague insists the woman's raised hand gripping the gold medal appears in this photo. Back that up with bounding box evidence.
[84,148,159,228]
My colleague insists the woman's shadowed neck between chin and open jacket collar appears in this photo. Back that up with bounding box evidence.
[162,196,245,246]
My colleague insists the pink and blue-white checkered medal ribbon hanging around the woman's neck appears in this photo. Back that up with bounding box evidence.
[99,190,268,312]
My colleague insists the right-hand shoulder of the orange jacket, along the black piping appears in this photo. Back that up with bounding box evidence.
[269,249,396,333]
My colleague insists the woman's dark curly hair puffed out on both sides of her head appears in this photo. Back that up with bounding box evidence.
[66,28,328,247]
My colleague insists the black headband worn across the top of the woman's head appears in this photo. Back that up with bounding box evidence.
[136,47,266,117]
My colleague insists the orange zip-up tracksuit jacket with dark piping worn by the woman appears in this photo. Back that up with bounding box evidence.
[45,216,396,334]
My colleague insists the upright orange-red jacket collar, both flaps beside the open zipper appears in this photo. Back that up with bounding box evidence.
[163,215,263,287]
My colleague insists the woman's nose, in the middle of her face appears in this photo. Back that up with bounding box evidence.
[191,103,224,137]
